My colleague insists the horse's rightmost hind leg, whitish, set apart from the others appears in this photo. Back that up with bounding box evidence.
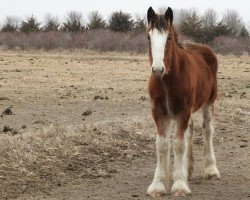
[202,106,220,179]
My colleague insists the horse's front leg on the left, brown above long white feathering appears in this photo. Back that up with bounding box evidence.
[147,101,171,197]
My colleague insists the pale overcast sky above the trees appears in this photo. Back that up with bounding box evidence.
[0,0,250,23]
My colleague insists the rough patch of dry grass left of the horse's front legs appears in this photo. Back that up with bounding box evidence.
[0,120,152,199]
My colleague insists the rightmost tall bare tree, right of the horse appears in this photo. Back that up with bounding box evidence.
[222,10,244,36]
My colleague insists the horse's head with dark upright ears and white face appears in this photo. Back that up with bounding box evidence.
[147,7,173,77]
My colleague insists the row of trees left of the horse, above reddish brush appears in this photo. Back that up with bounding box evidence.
[1,11,143,33]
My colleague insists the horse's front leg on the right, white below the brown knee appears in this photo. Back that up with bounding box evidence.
[171,113,191,196]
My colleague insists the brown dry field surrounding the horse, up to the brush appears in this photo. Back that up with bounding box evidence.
[0,51,250,200]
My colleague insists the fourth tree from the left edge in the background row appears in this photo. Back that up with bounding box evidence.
[62,11,85,32]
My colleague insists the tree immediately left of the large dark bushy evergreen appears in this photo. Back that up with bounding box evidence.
[88,11,106,29]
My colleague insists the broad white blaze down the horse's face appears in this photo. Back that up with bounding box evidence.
[149,29,168,71]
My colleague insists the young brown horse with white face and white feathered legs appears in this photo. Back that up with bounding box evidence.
[147,7,220,197]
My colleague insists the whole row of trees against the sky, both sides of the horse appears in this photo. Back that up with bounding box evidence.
[1,8,249,43]
